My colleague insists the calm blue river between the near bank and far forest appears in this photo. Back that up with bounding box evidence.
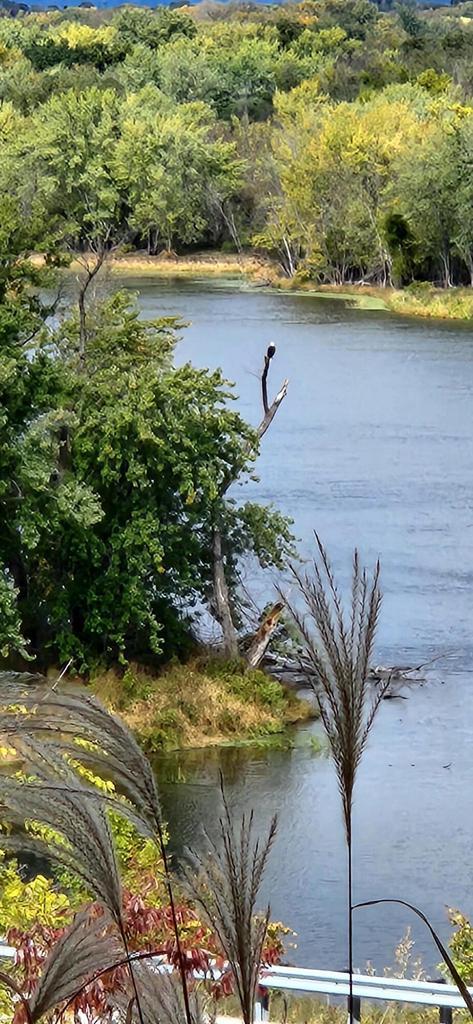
[118,278,473,971]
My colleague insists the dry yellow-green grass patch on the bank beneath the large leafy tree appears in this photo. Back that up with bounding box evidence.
[91,658,313,753]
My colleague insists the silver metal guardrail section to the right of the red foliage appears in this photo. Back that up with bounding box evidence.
[257,967,473,1024]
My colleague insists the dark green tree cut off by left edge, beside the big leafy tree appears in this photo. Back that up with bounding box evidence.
[0,221,62,657]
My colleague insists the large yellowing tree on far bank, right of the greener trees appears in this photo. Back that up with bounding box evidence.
[258,83,421,284]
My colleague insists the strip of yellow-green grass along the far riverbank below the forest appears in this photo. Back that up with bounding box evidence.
[109,250,473,321]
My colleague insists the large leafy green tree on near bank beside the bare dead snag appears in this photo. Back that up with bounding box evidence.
[0,294,290,666]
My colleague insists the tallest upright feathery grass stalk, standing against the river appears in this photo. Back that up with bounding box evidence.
[278,535,389,1022]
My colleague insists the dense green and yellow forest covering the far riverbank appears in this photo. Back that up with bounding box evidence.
[0,0,473,286]
